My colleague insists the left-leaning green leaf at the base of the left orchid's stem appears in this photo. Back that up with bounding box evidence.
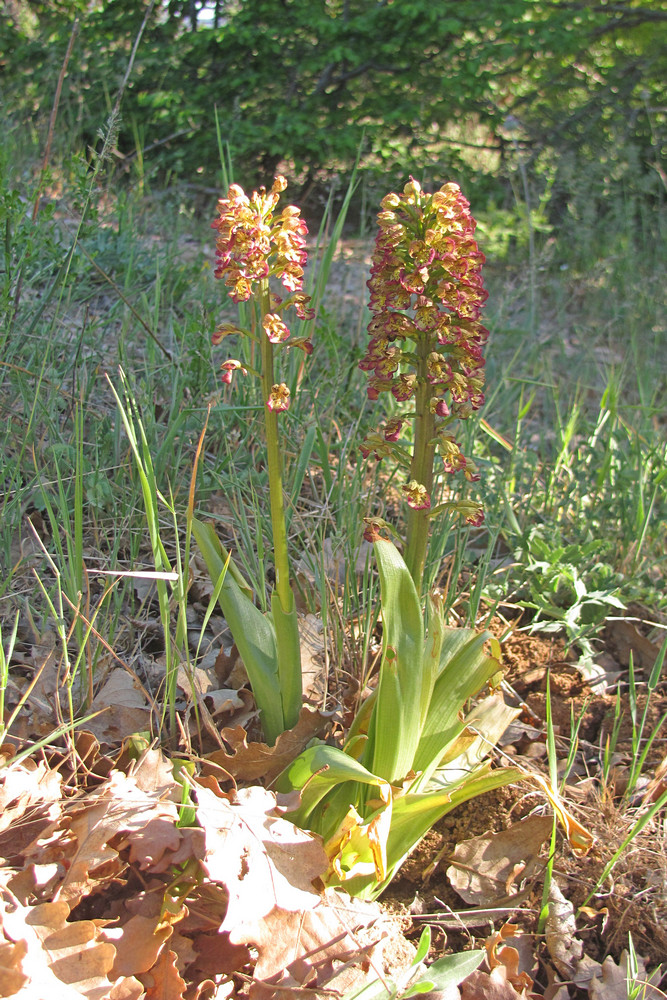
[192,518,288,744]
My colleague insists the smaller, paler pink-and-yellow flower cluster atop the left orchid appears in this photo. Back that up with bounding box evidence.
[211,175,314,410]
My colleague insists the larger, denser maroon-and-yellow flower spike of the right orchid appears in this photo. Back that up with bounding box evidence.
[359,178,488,520]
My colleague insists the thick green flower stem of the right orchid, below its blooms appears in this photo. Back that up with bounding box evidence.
[405,337,435,594]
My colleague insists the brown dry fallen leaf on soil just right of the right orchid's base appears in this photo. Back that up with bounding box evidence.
[447,816,553,906]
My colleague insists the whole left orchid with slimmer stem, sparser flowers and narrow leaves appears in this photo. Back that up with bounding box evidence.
[193,175,314,743]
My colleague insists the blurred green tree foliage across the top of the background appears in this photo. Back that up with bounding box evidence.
[0,0,667,221]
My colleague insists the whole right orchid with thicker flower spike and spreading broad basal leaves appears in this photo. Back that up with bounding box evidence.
[270,178,523,898]
